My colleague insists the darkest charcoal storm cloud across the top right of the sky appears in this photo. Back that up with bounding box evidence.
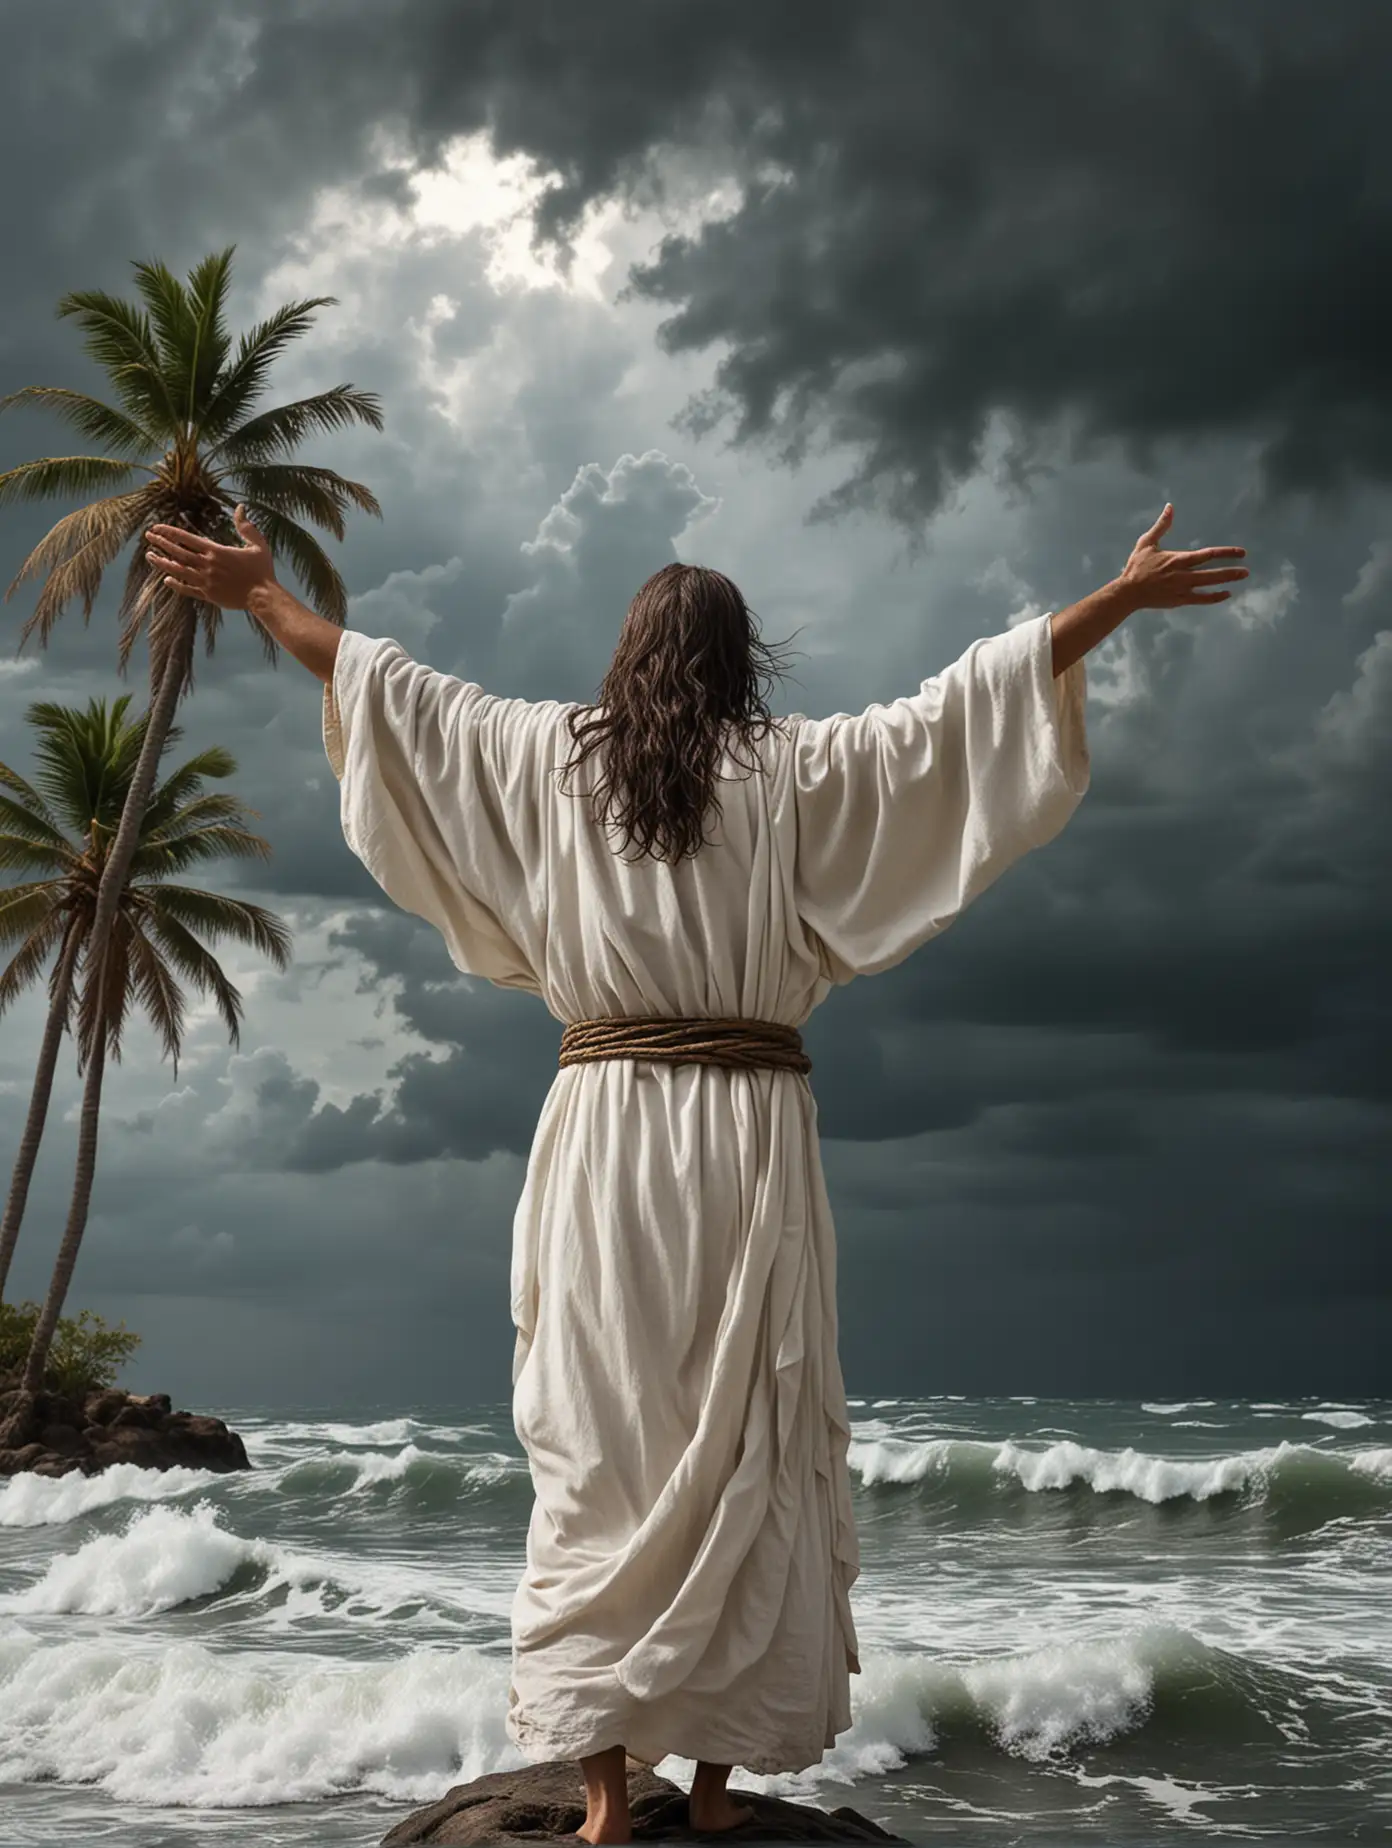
[238,0,1392,519]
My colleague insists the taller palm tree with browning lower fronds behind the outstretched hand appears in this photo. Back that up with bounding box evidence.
[0,246,383,1425]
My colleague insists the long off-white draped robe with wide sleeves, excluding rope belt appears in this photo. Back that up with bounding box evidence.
[324,612,1089,1772]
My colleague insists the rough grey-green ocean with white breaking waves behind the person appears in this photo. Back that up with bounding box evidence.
[0,1397,1392,1848]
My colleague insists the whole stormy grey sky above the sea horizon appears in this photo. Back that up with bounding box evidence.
[0,0,1392,1410]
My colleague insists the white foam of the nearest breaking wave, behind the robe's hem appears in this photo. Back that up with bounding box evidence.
[0,1624,1196,1807]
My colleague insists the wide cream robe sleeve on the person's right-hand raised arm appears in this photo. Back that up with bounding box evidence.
[793,612,1091,983]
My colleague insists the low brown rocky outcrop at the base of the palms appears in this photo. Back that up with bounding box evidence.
[0,1379,251,1477]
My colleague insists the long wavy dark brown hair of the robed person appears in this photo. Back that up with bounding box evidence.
[547,564,798,859]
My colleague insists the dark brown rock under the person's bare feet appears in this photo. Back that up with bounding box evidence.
[381,1759,904,1848]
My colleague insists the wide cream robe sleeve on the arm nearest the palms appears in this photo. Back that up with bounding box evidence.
[324,630,545,994]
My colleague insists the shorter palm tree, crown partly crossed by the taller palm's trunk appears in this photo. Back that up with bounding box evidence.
[0,693,290,1447]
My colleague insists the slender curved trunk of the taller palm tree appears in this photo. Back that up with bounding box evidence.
[0,606,194,1449]
